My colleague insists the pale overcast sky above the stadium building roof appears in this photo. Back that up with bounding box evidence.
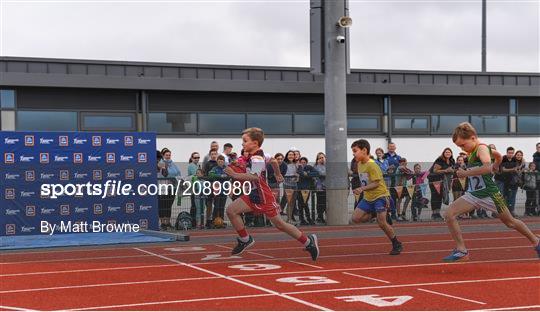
[0,0,540,72]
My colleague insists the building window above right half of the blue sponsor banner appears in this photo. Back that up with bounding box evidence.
[81,113,136,131]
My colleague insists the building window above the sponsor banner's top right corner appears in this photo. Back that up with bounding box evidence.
[148,113,197,133]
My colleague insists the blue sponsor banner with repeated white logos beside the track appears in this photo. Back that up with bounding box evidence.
[0,131,158,236]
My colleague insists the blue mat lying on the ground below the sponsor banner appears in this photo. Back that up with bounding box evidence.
[0,232,175,250]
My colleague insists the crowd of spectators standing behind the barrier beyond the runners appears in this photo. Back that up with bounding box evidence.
[157,141,540,229]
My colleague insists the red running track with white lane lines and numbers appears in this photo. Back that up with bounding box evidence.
[0,225,540,311]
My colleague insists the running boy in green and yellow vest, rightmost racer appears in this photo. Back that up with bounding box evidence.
[443,122,540,262]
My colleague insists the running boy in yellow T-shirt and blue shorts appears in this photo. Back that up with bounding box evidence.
[351,140,403,255]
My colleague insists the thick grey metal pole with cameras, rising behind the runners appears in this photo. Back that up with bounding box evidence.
[310,0,352,225]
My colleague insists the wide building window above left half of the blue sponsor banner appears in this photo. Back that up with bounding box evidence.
[16,111,77,131]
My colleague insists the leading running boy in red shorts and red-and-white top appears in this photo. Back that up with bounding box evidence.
[225,128,319,261]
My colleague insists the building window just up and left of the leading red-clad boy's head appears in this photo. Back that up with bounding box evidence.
[199,113,246,134]
